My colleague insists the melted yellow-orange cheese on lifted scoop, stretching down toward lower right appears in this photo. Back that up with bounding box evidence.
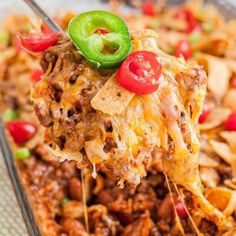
[33,31,232,229]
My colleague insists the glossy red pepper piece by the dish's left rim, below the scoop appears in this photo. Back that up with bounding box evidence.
[7,120,37,144]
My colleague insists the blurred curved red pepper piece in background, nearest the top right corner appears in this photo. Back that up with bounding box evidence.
[175,7,201,33]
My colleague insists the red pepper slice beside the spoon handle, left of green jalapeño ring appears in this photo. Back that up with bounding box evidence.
[17,32,59,52]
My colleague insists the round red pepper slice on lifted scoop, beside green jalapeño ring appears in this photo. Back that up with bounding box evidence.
[117,51,162,95]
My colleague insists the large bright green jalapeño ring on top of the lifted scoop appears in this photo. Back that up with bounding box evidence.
[68,11,132,68]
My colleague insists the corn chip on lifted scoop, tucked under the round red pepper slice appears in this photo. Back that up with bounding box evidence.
[91,76,135,116]
